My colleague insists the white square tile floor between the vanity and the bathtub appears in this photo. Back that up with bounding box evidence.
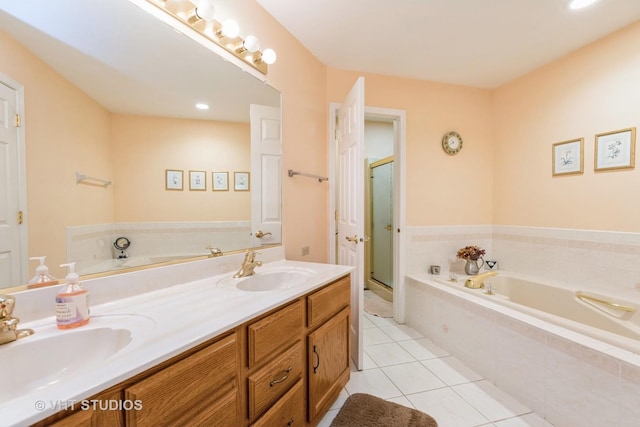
[319,291,551,427]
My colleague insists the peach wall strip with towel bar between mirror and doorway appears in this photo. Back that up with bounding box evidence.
[221,0,329,262]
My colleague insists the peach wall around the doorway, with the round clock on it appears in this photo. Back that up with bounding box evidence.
[327,68,494,226]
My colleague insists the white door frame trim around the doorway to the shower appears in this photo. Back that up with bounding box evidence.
[327,102,407,323]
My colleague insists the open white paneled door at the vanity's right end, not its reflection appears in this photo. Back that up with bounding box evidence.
[336,77,365,369]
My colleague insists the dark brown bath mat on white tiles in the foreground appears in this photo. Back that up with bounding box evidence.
[331,393,438,427]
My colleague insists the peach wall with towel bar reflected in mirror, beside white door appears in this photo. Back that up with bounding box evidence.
[0,31,113,276]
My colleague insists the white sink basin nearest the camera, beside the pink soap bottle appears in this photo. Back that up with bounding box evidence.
[0,315,155,402]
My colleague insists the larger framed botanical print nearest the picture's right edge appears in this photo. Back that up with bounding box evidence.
[594,128,636,171]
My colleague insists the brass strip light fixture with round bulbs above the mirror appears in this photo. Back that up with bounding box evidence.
[146,0,277,74]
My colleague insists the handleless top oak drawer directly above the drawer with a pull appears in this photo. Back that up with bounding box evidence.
[247,300,304,368]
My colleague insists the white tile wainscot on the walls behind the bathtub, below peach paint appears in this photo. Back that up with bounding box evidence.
[406,225,640,302]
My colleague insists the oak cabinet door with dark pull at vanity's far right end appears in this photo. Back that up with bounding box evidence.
[308,307,350,421]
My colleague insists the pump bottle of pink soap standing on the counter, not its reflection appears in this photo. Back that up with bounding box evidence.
[56,262,89,329]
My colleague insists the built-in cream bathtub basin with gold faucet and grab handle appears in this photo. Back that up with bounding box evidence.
[435,273,640,354]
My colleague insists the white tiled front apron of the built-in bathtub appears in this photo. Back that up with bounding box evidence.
[406,275,640,427]
